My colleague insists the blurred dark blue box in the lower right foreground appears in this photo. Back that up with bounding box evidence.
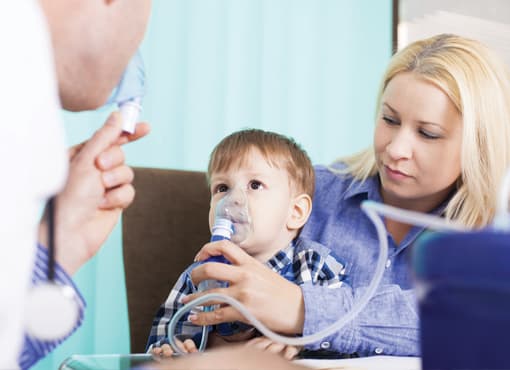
[412,230,510,370]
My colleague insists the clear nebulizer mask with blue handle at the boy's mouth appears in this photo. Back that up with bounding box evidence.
[168,187,253,353]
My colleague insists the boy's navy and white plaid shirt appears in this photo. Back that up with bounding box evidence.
[146,238,347,351]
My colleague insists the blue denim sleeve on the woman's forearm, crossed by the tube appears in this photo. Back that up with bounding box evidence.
[303,285,419,356]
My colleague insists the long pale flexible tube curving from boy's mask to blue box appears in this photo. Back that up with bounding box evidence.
[168,171,510,354]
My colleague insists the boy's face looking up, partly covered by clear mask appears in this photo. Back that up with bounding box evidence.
[209,148,296,261]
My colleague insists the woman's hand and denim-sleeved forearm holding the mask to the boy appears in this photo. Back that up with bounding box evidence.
[179,241,419,356]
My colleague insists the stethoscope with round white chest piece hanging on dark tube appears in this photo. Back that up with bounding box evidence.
[25,197,80,340]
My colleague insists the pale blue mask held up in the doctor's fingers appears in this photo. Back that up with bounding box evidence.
[106,51,145,134]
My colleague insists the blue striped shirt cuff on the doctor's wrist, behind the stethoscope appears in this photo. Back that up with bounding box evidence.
[18,245,86,369]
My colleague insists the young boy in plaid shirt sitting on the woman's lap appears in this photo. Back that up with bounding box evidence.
[147,129,346,357]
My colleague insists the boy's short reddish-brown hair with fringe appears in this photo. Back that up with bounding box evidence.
[207,129,315,198]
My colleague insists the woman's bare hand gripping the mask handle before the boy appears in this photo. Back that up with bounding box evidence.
[182,240,304,334]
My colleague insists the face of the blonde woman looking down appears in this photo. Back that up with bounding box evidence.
[374,72,462,212]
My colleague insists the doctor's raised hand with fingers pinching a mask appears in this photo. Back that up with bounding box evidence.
[39,112,150,275]
